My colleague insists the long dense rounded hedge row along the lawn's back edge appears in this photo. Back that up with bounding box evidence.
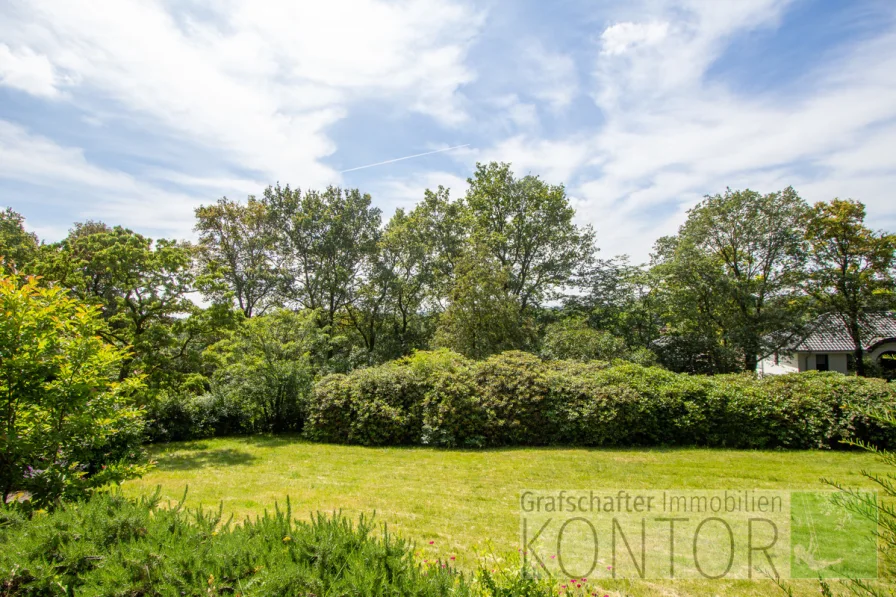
[305,351,896,448]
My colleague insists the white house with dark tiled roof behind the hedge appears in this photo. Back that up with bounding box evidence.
[757,312,896,375]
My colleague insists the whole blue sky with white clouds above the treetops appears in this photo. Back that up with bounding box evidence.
[0,0,896,263]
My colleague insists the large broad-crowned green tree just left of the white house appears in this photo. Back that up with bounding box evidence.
[664,187,807,371]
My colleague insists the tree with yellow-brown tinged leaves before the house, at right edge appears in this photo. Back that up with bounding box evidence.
[805,199,896,376]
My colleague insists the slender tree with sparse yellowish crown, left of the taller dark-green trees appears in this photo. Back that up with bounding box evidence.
[195,197,281,317]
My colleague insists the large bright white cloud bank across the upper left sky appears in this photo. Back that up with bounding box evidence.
[0,0,481,185]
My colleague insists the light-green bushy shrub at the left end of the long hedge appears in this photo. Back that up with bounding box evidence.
[207,309,327,431]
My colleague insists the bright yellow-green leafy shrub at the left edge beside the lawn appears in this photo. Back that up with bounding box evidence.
[0,271,144,505]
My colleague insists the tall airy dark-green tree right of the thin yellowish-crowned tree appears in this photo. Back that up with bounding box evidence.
[264,185,381,328]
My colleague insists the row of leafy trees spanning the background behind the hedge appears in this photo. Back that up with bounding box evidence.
[0,163,896,393]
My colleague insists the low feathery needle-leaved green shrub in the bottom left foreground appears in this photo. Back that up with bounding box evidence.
[0,494,484,597]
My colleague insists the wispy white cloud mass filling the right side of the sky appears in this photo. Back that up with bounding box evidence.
[481,0,896,261]
